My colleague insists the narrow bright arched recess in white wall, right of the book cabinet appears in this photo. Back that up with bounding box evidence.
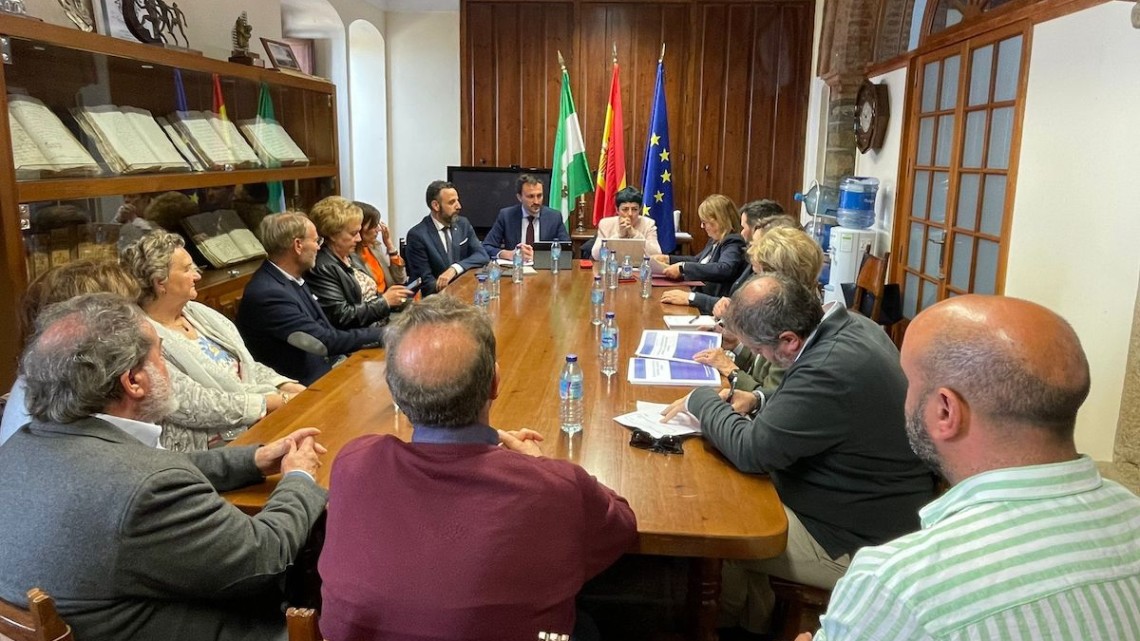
[349,21,392,214]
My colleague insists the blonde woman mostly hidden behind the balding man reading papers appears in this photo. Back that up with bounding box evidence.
[693,227,823,391]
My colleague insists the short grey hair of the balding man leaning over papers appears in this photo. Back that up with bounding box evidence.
[724,273,823,344]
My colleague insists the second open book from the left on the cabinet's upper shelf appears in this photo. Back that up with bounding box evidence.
[71,105,190,173]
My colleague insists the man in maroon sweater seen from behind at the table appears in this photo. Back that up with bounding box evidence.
[319,297,637,641]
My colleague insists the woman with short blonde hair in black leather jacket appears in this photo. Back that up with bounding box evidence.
[304,196,413,330]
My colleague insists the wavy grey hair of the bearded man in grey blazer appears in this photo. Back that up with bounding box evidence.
[19,293,154,423]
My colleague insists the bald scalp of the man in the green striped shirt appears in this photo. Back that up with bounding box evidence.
[903,295,1089,441]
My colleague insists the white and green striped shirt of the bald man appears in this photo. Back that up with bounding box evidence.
[815,456,1140,641]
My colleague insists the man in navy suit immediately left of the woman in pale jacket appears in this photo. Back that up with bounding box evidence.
[483,173,570,262]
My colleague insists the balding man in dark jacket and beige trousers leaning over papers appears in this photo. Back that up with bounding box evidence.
[667,274,934,633]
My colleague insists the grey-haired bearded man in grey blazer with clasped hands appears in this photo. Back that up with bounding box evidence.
[0,294,327,641]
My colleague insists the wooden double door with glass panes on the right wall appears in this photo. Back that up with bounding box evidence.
[896,25,1028,318]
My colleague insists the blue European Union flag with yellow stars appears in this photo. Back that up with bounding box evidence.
[642,57,677,253]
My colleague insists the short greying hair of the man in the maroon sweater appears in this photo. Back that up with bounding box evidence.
[384,295,495,428]
